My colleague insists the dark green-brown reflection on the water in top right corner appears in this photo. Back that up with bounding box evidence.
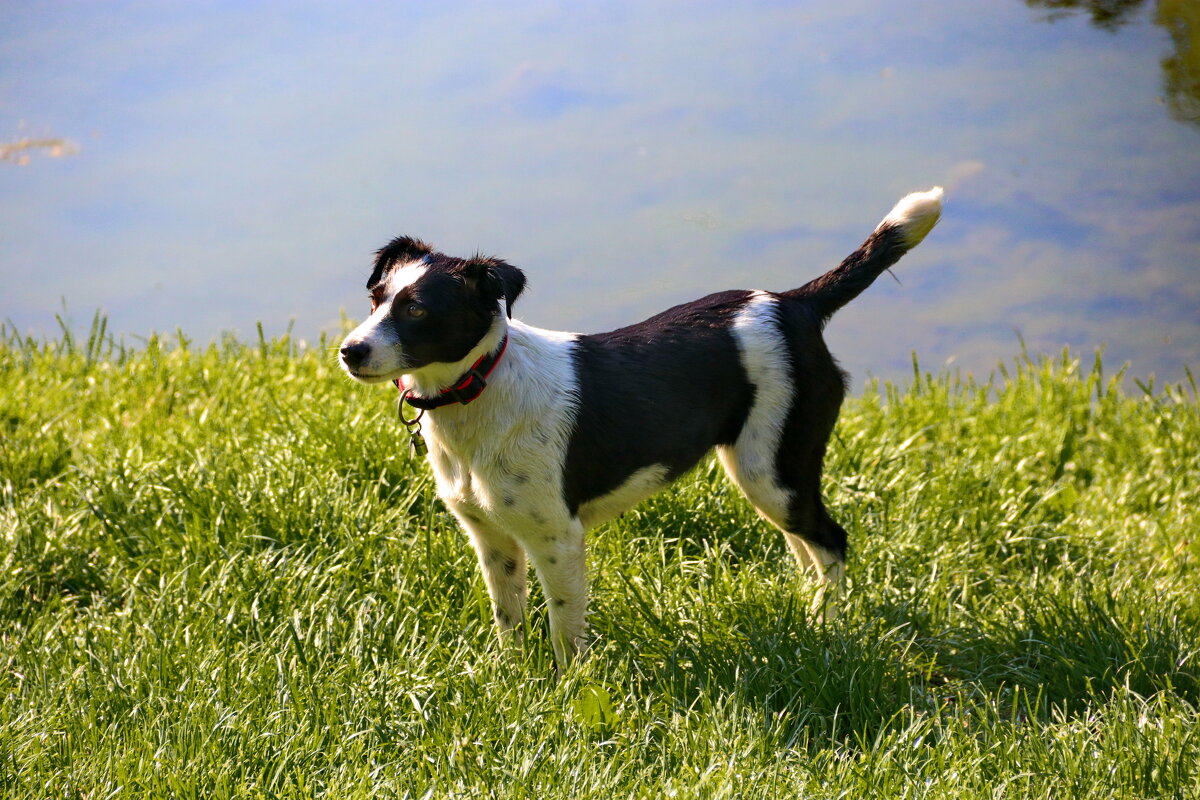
[1025,0,1200,125]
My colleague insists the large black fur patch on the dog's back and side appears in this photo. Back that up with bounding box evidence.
[563,291,754,513]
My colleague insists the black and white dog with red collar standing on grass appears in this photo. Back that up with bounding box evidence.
[341,188,942,664]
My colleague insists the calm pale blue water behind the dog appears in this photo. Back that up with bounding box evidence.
[0,0,1200,381]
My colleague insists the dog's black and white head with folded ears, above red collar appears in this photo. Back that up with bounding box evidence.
[341,236,524,384]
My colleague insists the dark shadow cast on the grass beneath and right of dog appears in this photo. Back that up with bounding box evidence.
[600,575,1200,746]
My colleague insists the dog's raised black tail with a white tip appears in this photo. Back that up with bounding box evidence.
[782,186,942,325]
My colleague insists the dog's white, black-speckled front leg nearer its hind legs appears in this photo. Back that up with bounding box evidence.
[527,519,588,667]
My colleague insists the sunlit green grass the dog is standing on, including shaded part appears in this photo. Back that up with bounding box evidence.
[0,316,1200,800]
